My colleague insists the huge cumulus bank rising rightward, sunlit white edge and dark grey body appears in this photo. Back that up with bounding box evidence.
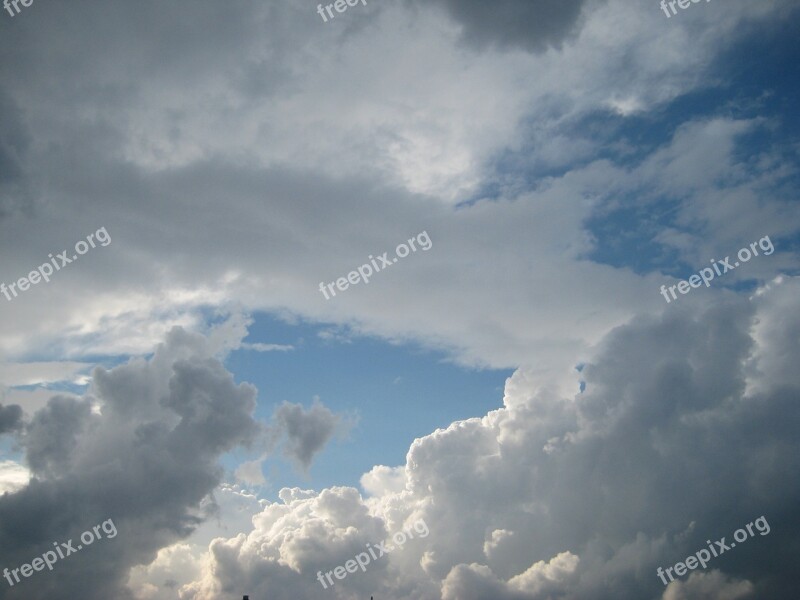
[181,277,800,600]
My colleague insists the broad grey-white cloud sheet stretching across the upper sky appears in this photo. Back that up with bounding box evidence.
[0,0,796,385]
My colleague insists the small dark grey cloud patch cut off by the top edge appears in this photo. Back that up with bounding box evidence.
[418,0,587,52]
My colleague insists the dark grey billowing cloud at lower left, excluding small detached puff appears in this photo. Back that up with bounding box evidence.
[0,329,262,600]
